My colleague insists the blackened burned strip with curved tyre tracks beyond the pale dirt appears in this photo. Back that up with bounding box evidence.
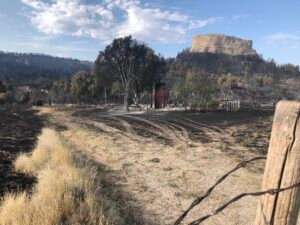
[73,109,273,154]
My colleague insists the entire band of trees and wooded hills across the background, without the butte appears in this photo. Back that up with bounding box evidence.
[0,36,300,108]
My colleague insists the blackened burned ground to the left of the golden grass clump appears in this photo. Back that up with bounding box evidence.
[0,107,43,197]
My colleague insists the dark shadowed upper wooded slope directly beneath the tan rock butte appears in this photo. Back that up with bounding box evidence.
[171,50,300,78]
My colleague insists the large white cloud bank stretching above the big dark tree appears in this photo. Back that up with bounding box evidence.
[21,0,217,42]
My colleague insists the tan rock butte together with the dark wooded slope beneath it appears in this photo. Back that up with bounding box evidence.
[169,34,300,78]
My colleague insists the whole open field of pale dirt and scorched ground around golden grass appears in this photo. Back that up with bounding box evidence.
[0,107,273,225]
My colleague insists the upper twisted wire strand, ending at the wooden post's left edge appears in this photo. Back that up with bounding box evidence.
[174,156,266,225]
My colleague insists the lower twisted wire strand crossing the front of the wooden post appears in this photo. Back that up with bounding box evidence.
[188,182,300,225]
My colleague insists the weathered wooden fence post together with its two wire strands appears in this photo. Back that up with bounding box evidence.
[174,101,300,225]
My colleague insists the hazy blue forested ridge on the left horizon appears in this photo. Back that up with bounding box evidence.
[0,52,92,86]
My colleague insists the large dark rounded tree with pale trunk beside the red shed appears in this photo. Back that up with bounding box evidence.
[95,36,161,110]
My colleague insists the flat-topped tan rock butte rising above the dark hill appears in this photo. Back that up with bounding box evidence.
[190,34,257,55]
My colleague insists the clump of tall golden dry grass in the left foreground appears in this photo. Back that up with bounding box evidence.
[0,129,109,225]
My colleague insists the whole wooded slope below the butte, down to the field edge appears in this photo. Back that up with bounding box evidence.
[166,50,300,108]
